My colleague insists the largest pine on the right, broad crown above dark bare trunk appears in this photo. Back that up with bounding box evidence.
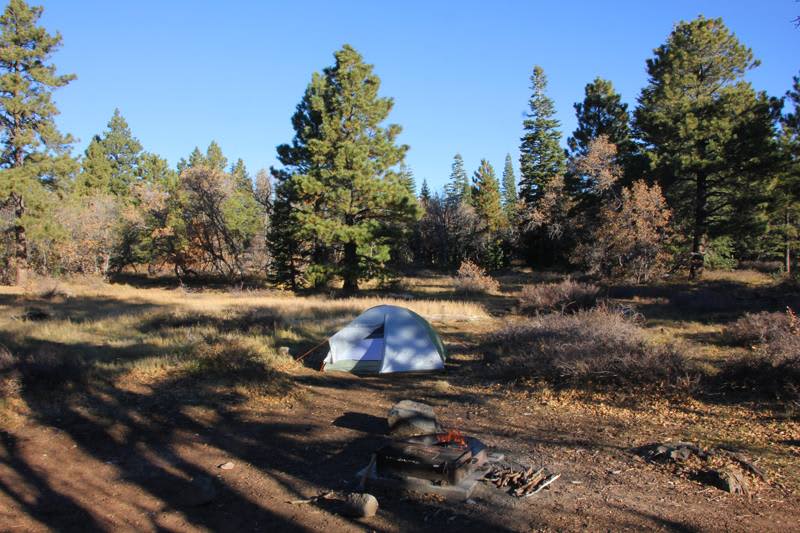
[635,16,776,276]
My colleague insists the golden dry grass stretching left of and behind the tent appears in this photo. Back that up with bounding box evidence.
[0,280,487,422]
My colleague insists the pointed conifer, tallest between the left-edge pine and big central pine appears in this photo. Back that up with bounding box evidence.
[100,109,142,197]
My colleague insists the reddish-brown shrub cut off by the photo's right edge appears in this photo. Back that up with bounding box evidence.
[721,308,800,398]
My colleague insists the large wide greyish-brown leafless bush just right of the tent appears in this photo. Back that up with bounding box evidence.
[490,307,691,386]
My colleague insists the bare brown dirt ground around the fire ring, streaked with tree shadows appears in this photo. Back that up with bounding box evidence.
[0,272,800,532]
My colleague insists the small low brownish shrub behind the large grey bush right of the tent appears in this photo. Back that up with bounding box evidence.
[519,279,600,313]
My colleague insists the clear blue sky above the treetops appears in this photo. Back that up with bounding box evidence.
[34,0,800,188]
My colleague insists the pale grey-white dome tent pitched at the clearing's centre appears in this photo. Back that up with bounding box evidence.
[323,305,446,374]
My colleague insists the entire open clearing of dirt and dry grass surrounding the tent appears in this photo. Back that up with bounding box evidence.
[0,277,800,531]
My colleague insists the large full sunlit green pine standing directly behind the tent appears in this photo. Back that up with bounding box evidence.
[278,45,418,291]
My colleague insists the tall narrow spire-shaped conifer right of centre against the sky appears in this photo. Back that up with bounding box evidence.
[519,65,566,206]
